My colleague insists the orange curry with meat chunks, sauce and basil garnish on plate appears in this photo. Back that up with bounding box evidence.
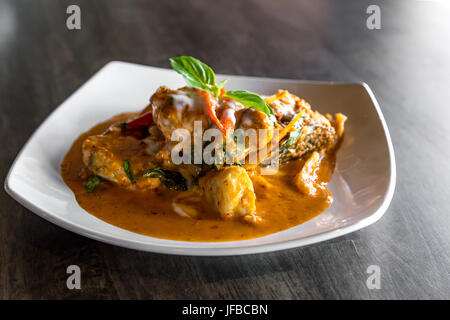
[61,56,346,242]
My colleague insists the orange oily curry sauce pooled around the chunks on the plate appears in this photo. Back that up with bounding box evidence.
[61,113,335,242]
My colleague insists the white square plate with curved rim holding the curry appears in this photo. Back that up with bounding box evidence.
[5,62,395,255]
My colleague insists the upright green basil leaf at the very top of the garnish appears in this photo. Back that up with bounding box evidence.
[169,56,217,95]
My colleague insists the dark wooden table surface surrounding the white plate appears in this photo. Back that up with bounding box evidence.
[0,0,450,299]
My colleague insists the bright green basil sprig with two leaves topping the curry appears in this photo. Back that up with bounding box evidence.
[169,56,275,120]
